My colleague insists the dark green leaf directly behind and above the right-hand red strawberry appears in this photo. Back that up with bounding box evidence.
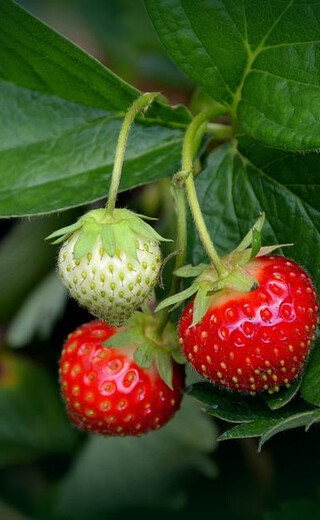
[188,139,320,300]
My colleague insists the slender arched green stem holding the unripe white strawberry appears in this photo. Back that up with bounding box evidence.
[106,92,158,215]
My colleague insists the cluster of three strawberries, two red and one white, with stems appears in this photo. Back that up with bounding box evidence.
[49,95,319,435]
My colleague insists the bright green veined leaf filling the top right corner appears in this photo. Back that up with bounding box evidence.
[145,0,320,150]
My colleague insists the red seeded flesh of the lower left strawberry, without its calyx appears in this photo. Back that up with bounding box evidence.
[60,321,184,436]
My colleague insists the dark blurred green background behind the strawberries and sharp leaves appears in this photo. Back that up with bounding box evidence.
[0,0,320,520]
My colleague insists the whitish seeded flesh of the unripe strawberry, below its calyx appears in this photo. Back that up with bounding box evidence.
[58,231,161,326]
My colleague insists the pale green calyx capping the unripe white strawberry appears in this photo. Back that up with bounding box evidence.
[47,208,169,260]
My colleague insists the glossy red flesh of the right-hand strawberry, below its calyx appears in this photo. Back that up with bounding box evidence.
[179,256,318,394]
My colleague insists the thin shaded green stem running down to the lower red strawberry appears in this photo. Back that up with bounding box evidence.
[155,187,187,337]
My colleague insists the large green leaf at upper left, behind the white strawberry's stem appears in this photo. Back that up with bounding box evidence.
[0,0,190,217]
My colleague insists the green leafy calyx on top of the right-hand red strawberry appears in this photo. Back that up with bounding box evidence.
[156,213,292,326]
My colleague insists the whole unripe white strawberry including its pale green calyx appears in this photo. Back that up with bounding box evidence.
[49,209,168,326]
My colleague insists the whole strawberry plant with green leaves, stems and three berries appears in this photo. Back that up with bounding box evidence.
[0,0,320,520]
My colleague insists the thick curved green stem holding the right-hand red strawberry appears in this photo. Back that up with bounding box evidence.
[182,108,227,276]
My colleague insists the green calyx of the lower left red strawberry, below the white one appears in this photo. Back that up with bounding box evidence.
[103,312,185,390]
